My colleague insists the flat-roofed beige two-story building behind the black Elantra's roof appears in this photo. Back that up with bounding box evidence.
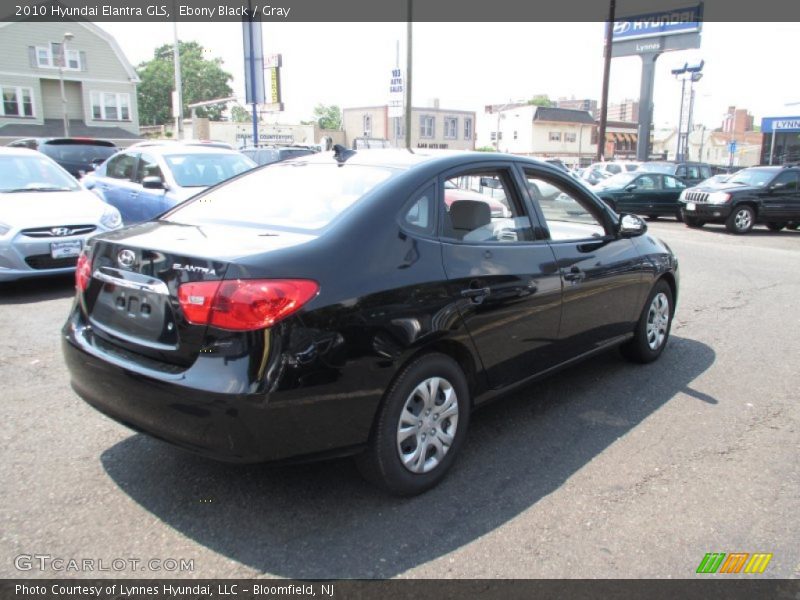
[342,100,475,150]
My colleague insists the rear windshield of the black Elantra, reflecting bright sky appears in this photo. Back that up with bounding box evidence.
[166,163,396,230]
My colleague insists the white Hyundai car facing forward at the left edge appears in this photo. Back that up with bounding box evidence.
[0,147,122,282]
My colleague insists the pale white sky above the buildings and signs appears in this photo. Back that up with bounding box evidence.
[98,22,800,128]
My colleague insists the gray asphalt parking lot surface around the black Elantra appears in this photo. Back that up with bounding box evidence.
[0,220,800,579]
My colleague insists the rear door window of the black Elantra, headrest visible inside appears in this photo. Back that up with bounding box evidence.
[442,169,533,244]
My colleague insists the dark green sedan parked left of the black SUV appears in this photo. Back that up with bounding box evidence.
[593,171,686,221]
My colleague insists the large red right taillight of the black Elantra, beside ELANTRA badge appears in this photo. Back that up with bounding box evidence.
[178,279,319,331]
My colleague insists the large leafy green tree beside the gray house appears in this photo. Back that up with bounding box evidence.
[136,42,233,125]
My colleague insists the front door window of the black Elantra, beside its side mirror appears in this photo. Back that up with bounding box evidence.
[525,169,606,241]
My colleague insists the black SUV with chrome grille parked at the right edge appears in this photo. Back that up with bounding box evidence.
[680,165,800,233]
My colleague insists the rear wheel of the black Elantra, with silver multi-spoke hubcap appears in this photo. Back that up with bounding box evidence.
[356,353,471,496]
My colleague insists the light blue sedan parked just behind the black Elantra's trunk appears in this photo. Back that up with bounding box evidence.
[81,144,256,225]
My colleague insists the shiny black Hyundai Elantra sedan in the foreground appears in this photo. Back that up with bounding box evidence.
[63,147,678,494]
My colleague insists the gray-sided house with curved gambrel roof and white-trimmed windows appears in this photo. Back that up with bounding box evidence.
[0,21,139,145]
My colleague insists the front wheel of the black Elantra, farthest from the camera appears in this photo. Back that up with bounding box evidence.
[620,279,675,364]
